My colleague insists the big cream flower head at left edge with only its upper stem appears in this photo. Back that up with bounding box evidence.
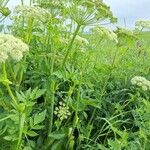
[0,33,29,104]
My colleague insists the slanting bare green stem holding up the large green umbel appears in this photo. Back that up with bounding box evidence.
[62,24,81,67]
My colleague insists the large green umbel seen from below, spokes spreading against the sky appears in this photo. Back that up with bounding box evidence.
[68,0,116,26]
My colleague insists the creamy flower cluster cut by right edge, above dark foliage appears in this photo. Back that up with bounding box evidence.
[131,76,150,91]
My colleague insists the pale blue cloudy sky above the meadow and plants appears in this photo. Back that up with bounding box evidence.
[8,0,150,28]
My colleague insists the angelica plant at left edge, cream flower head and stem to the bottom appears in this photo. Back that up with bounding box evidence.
[0,33,29,150]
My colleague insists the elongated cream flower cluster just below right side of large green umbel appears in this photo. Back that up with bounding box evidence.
[93,26,118,43]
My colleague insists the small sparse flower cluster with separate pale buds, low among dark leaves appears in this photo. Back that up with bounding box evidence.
[54,102,71,121]
